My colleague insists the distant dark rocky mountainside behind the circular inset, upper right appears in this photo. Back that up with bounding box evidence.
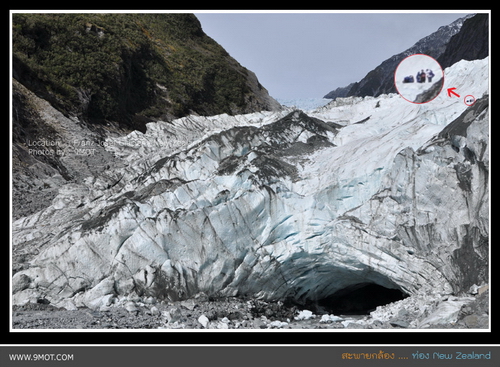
[324,14,478,99]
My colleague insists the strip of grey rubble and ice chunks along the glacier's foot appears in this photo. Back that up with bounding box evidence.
[12,286,489,332]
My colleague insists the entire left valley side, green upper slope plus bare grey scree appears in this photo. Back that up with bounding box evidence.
[12,13,281,218]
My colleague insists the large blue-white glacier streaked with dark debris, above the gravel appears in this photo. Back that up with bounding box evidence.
[12,58,489,326]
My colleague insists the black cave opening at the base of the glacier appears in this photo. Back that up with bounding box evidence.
[310,283,408,315]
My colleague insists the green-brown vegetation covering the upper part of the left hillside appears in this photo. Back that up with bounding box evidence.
[12,13,256,128]
